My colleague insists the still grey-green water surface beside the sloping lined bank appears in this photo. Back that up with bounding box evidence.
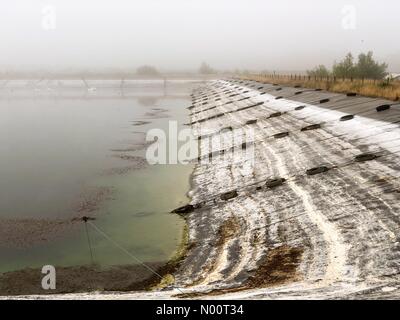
[0,80,197,272]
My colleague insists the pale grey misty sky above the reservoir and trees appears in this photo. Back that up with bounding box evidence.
[0,0,400,72]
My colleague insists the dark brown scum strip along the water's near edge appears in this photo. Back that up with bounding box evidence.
[0,222,188,299]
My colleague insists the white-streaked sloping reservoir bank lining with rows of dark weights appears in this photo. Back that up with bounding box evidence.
[7,80,400,299]
